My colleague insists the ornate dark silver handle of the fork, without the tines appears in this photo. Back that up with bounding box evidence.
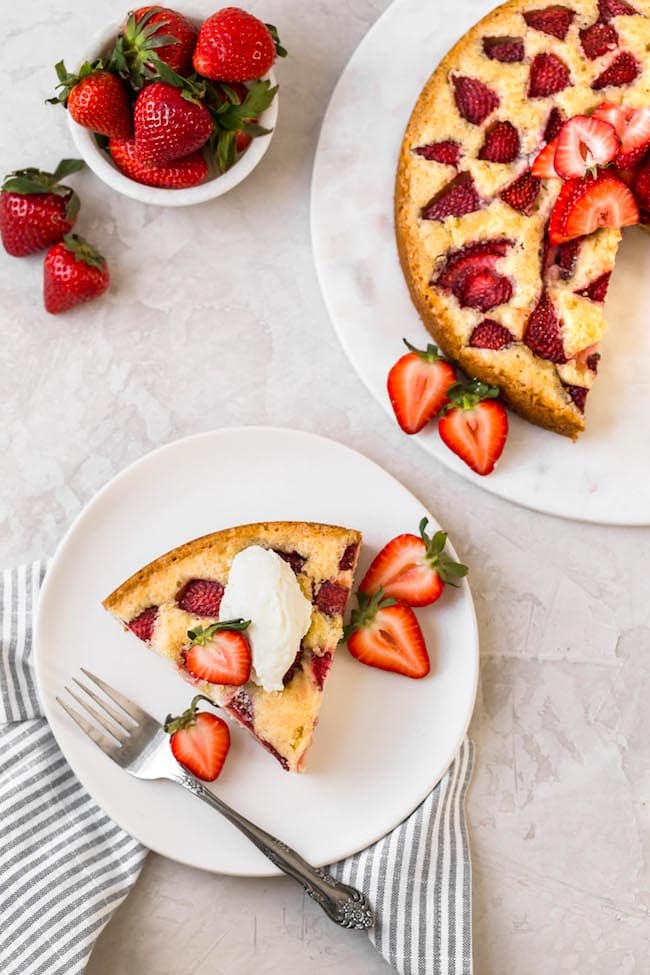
[174,769,374,930]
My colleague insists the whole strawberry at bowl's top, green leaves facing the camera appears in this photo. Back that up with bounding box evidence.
[109,7,197,90]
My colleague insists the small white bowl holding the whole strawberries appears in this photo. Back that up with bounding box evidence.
[68,5,278,207]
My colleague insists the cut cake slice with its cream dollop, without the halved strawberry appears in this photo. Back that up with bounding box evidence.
[103,522,361,771]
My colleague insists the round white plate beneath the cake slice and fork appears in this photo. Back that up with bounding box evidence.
[35,427,478,876]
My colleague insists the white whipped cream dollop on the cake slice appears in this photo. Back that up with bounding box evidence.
[219,545,312,691]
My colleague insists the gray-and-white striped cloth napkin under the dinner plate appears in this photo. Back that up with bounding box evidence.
[0,562,473,975]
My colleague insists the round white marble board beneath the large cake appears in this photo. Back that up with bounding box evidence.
[311,0,650,525]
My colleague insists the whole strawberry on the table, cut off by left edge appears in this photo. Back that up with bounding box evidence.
[0,159,84,257]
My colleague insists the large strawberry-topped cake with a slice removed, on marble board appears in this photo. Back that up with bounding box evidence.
[395,0,650,438]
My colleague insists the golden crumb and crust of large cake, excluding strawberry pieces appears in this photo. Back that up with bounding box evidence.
[394,0,650,438]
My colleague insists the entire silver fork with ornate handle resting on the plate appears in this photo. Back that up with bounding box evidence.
[57,667,374,929]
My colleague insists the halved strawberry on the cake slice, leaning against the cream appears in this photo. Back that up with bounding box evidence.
[185,620,252,687]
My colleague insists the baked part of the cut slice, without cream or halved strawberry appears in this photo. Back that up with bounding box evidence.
[103,522,361,771]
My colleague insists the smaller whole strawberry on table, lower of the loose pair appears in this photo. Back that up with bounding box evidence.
[43,234,110,315]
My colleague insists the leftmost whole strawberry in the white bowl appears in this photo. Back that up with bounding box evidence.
[47,61,133,139]
